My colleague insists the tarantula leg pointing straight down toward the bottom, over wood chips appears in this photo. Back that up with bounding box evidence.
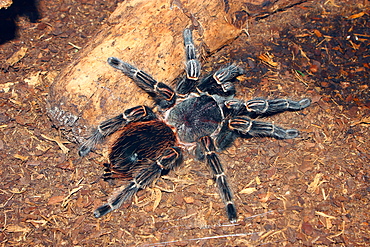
[199,136,237,222]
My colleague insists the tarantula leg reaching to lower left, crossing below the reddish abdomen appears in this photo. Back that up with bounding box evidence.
[94,147,182,218]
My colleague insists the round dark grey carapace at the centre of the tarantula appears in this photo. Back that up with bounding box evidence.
[167,95,223,143]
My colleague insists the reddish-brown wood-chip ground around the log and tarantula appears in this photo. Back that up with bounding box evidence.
[0,0,370,246]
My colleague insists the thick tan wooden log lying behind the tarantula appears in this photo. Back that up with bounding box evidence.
[47,0,246,141]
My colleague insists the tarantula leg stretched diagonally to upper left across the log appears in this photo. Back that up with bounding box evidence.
[108,57,176,109]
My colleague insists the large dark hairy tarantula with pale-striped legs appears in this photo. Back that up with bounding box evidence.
[79,29,311,222]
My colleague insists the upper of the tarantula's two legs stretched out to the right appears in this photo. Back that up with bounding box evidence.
[225,98,311,117]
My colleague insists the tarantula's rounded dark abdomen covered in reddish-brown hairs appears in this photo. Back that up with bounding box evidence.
[109,119,176,177]
